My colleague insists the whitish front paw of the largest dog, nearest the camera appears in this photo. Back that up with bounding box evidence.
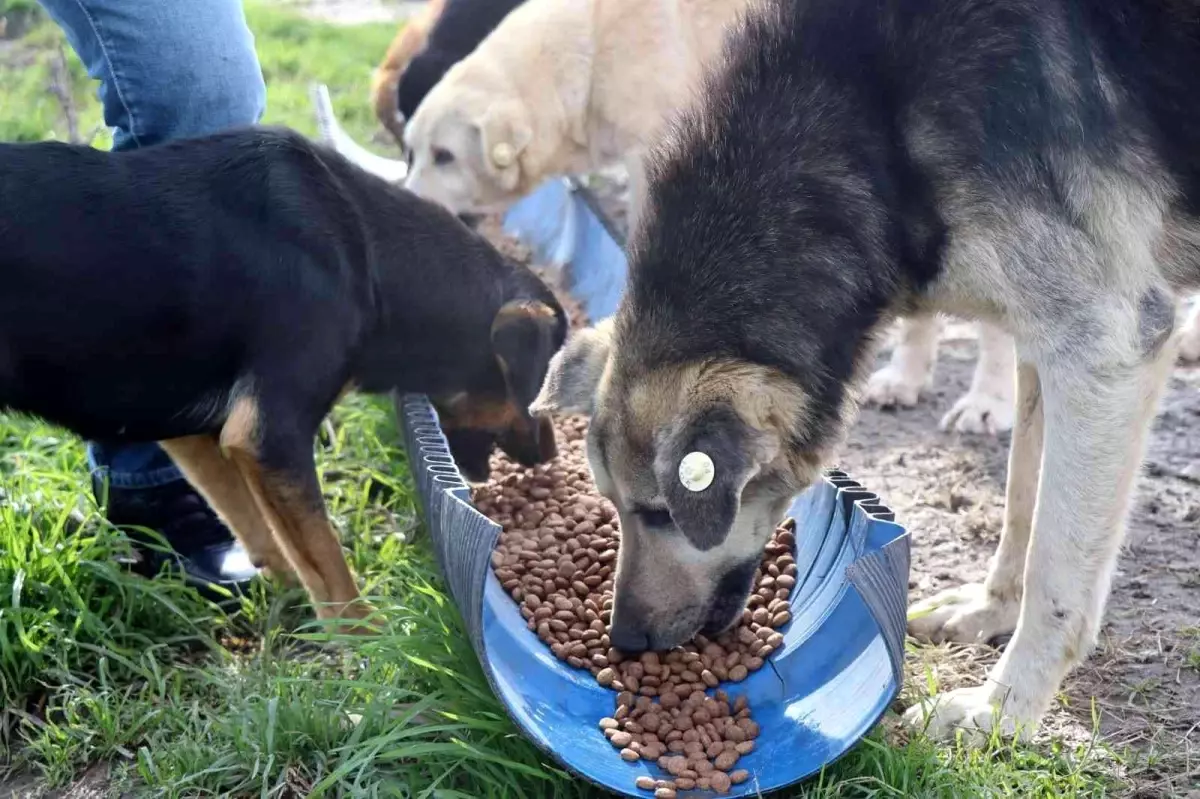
[904,683,1032,746]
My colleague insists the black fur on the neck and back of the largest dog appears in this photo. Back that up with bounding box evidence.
[617,0,1200,450]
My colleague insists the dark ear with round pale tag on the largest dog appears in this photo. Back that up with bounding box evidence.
[654,404,779,551]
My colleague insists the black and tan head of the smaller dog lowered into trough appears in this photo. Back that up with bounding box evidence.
[433,299,566,482]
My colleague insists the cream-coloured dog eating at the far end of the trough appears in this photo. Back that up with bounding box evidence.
[404,0,749,218]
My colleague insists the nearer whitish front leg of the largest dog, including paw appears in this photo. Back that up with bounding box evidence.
[905,319,1176,743]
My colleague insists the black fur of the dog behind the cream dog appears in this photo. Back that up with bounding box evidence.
[396,0,523,120]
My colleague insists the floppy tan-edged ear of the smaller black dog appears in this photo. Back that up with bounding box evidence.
[492,300,566,416]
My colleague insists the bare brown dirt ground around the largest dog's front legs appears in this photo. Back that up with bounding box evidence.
[841,324,1200,797]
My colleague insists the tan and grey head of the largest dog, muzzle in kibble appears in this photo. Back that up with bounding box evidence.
[533,322,821,651]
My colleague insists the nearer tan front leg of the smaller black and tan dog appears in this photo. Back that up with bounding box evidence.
[221,397,371,619]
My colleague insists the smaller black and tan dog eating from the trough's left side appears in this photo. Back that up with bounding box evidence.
[0,128,566,618]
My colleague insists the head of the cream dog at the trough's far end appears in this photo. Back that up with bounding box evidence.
[404,59,533,214]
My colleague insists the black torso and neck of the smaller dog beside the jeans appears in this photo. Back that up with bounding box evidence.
[0,128,545,440]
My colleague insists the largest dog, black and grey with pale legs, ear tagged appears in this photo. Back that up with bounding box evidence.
[533,0,1200,735]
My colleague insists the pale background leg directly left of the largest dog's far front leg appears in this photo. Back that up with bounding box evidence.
[940,322,1016,435]
